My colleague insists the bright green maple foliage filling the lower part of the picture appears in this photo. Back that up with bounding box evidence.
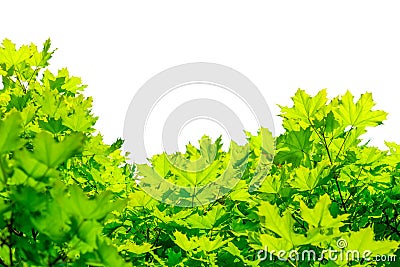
[0,40,400,266]
